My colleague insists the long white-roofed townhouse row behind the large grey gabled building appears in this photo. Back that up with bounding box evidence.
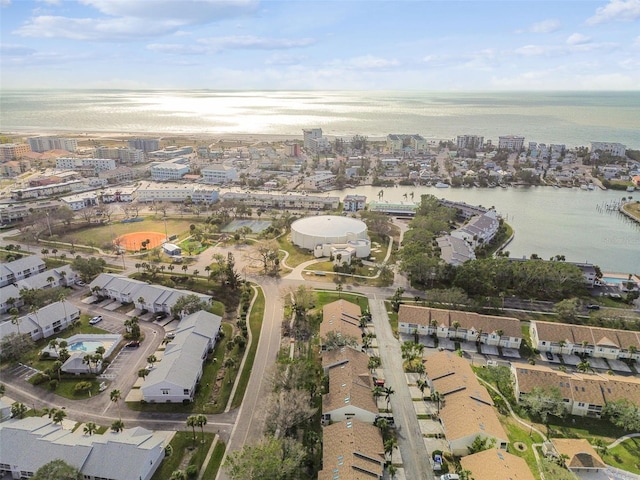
[89,273,213,314]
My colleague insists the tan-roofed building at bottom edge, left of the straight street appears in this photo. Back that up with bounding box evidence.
[318,420,385,480]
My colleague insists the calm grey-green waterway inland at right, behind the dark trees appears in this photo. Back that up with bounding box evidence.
[327,186,640,274]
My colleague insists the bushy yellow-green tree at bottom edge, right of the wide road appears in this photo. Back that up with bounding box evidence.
[224,437,306,480]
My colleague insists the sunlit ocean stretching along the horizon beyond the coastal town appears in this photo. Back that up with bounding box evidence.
[0,90,640,149]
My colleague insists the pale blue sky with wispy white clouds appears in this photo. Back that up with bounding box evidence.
[0,0,640,91]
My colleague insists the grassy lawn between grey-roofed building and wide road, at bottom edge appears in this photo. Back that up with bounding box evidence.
[151,427,214,480]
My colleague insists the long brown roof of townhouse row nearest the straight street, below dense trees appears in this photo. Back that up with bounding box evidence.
[398,305,522,338]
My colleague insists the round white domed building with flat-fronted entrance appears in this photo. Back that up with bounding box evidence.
[291,215,371,263]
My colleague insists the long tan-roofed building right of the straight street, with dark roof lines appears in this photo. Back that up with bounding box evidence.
[425,351,509,457]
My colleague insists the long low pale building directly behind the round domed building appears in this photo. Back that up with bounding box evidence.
[222,192,340,210]
